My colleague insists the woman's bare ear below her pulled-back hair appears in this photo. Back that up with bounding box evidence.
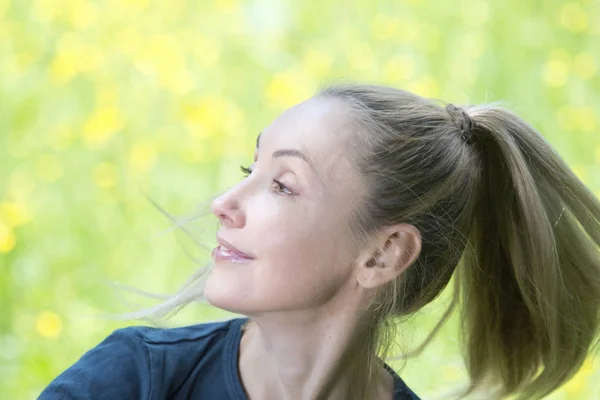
[356,224,421,289]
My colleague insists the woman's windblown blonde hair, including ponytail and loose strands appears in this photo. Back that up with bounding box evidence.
[132,84,600,399]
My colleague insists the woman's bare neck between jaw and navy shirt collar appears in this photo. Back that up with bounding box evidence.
[240,286,393,400]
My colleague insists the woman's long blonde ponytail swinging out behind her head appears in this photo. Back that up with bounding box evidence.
[457,106,600,399]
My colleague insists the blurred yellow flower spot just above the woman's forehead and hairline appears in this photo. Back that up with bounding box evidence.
[266,69,314,108]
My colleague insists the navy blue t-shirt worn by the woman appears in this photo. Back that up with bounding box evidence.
[38,318,419,400]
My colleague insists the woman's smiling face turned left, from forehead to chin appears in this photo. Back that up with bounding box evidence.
[204,98,364,315]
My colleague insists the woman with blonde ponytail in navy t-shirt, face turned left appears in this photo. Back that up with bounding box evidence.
[40,85,600,400]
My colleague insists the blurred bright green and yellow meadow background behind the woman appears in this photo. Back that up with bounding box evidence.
[0,0,600,399]
